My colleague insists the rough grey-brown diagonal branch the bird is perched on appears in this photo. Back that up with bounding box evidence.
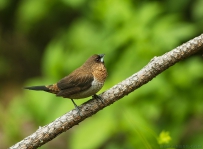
[10,34,203,149]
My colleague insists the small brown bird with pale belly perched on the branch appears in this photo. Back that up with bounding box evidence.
[25,54,107,112]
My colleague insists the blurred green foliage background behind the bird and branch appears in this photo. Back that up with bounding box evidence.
[0,0,203,149]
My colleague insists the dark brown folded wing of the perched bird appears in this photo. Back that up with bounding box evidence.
[57,73,94,97]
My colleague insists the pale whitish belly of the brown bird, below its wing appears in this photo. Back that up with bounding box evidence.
[69,79,104,99]
